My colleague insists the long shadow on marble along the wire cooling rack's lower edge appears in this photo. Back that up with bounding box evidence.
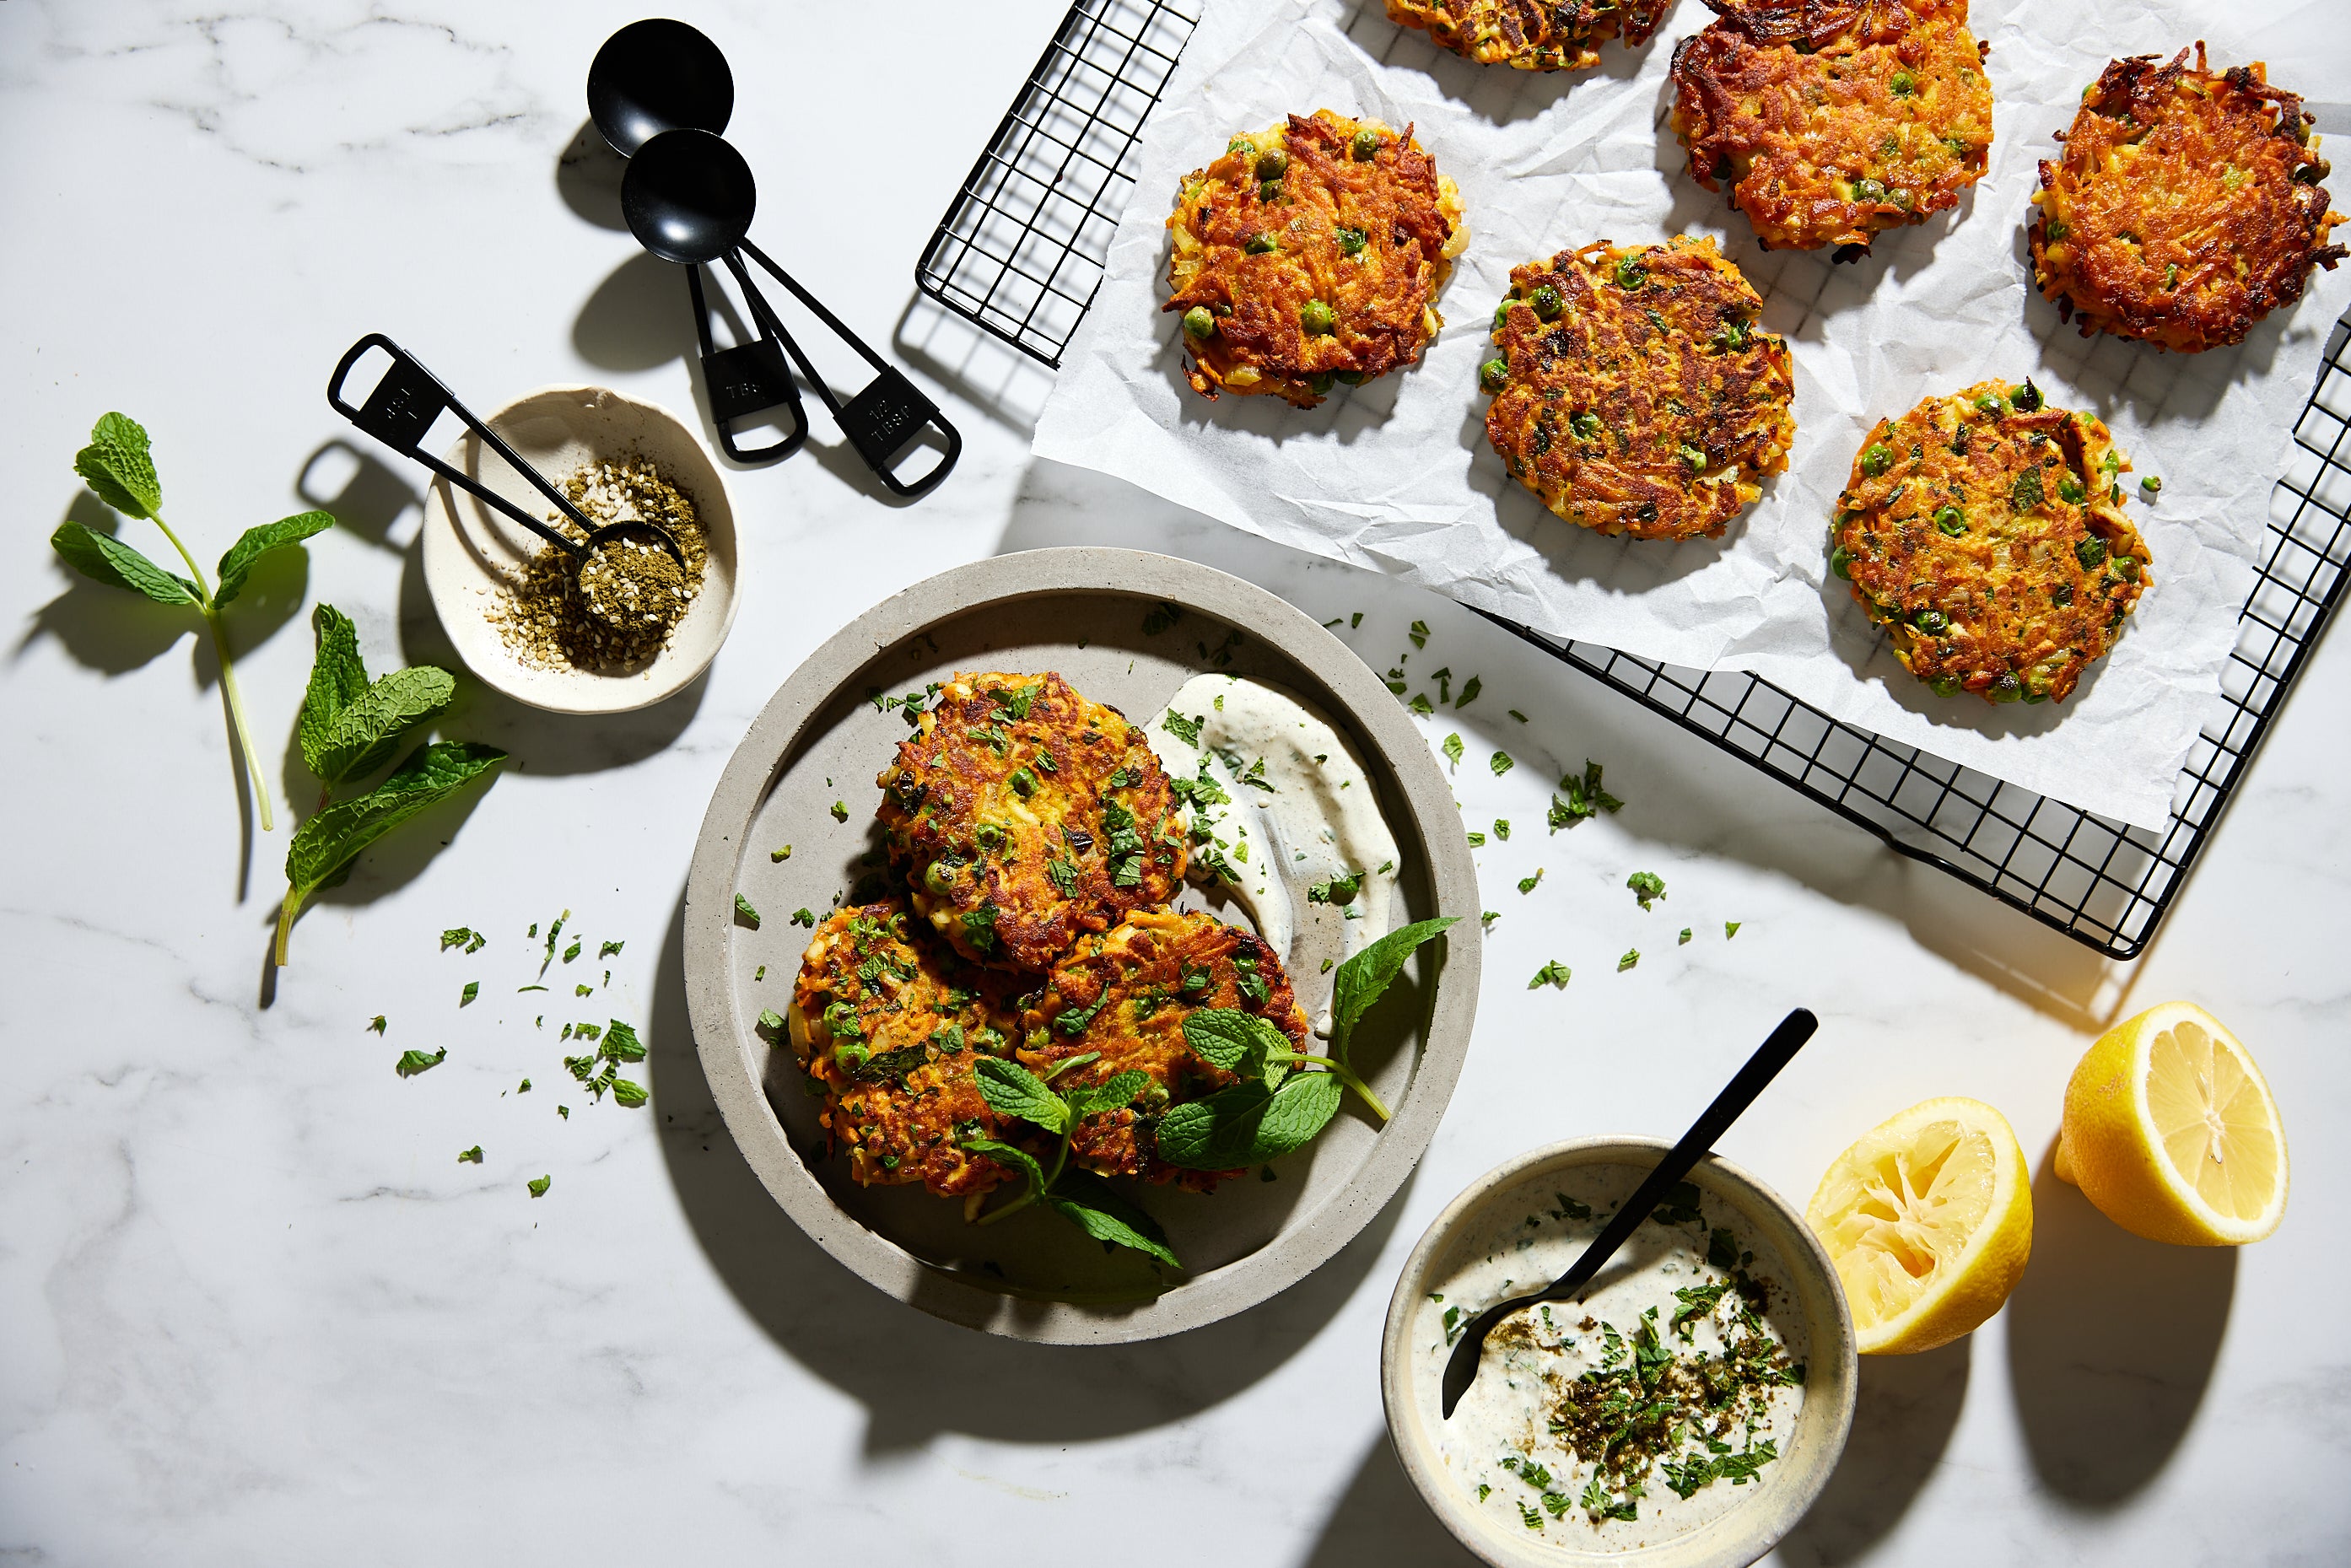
[997,458,2135,1030]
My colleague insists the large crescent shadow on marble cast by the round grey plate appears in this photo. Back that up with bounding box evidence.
[646,900,1382,1458]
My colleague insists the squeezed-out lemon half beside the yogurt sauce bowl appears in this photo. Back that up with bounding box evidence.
[1804,1098,2034,1356]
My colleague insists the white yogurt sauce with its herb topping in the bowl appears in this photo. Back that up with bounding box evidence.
[1413,1166,1808,1551]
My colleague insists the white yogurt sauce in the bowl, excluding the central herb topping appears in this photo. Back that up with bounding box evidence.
[1413,1166,1808,1551]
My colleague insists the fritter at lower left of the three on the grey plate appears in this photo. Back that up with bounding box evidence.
[785,900,1018,1197]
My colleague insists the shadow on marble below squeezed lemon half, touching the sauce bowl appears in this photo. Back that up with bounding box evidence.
[1780,1335,1975,1568]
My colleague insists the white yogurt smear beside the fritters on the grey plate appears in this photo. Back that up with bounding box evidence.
[1142,675,1401,992]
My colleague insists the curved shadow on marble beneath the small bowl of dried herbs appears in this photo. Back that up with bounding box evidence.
[387,531,710,775]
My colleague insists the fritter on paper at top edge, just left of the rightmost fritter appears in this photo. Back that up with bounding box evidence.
[1674,0,1992,249]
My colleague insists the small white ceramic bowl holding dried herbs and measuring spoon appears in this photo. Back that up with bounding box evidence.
[423,385,736,712]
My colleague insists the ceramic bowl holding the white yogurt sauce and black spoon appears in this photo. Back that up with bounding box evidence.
[1380,1138,1860,1568]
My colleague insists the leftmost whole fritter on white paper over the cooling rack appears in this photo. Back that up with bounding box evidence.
[1164,108,1469,409]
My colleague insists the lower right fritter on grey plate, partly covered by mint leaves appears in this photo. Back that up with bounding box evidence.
[1018,910,1308,1192]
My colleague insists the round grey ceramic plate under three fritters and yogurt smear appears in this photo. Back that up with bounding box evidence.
[687,550,1479,1342]
